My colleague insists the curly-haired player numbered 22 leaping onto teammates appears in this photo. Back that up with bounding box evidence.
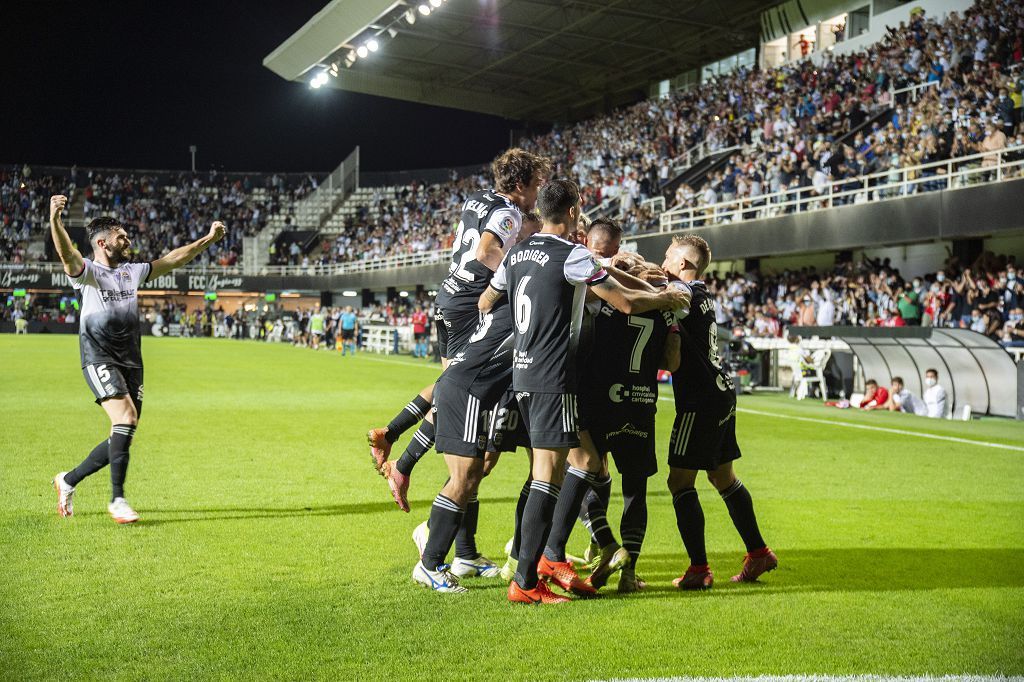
[367,148,551,511]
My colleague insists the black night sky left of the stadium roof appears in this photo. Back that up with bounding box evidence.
[0,0,512,171]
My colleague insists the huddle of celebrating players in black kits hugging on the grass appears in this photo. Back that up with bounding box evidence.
[368,148,778,603]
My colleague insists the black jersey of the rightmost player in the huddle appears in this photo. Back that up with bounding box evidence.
[669,281,736,412]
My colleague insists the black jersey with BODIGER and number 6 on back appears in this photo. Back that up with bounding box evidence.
[490,232,608,393]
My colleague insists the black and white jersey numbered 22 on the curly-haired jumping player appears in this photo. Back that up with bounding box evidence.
[436,189,522,306]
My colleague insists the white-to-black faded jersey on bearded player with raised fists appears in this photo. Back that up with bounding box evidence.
[68,258,153,368]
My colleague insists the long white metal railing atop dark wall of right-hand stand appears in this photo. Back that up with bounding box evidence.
[660,145,1024,232]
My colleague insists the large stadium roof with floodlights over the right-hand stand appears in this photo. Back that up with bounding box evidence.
[263,0,778,121]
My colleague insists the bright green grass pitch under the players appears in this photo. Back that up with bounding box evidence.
[0,336,1024,680]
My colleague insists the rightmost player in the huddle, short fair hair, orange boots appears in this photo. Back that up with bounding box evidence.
[662,235,778,590]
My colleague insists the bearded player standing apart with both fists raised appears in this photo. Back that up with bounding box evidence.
[50,195,224,523]
